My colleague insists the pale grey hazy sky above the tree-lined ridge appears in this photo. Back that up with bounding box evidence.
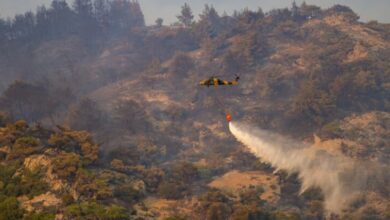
[0,0,390,24]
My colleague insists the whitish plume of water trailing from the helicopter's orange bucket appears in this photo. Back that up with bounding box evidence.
[229,122,359,213]
